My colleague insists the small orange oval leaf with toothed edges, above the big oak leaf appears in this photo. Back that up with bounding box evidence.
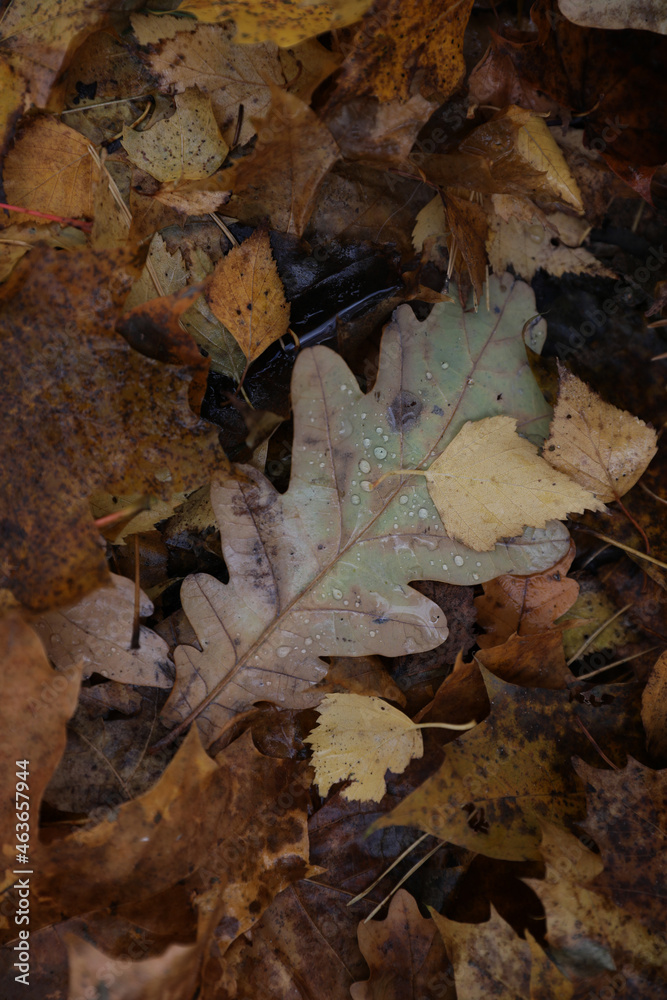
[206,229,290,365]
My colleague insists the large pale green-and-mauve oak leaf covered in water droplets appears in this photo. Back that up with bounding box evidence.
[159,277,569,743]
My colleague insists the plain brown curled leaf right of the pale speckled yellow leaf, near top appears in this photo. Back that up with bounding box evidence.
[220,90,339,236]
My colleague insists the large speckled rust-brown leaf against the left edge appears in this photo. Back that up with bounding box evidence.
[0,250,226,610]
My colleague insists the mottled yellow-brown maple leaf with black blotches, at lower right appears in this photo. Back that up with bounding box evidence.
[370,671,640,861]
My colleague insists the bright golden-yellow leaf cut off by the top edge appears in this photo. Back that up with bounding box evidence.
[179,0,372,48]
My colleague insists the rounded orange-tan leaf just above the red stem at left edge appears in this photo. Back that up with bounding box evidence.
[3,117,100,224]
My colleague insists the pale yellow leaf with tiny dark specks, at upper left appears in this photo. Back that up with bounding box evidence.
[122,87,229,184]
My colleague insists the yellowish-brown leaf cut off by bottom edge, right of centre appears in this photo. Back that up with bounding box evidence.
[432,907,574,1000]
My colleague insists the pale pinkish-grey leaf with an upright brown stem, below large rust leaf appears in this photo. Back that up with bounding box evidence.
[35,575,171,688]
